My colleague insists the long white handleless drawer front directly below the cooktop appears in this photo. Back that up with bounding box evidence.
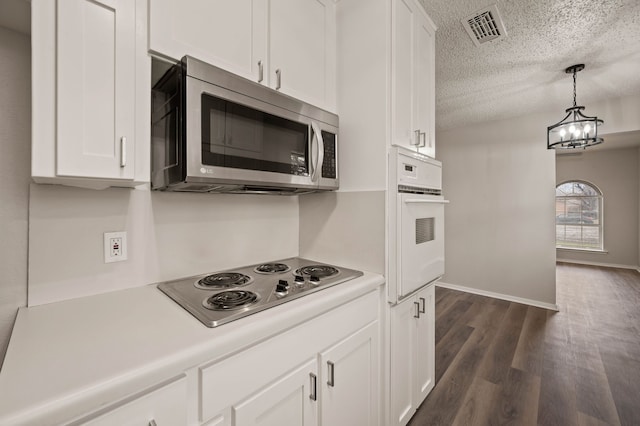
[199,290,380,422]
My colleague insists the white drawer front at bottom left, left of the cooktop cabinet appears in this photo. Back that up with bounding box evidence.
[69,374,187,426]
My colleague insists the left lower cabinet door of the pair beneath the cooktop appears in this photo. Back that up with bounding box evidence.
[233,358,320,426]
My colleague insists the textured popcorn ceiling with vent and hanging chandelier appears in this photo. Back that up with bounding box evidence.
[420,0,640,129]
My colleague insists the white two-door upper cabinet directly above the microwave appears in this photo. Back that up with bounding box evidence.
[149,0,336,111]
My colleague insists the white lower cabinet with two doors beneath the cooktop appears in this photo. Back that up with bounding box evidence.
[199,292,381,426]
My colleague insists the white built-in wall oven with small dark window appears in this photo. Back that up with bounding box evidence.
[388,147,448,304]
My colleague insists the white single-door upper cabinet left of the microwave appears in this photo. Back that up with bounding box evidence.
[31,0,148,188]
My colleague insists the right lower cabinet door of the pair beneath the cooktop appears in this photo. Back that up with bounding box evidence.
[320,321,379,426]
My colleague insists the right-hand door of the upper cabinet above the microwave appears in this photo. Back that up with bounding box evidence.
[269,0,335,107]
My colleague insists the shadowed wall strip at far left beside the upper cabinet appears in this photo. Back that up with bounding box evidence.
[0,27,31,364]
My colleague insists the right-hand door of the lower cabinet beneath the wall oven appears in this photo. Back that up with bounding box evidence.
[414,285,435,408]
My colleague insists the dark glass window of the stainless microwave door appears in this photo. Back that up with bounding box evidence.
[202,95,309,175]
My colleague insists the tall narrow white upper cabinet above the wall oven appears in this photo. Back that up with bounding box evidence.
[391,0,435,157]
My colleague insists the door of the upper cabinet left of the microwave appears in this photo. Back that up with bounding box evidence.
[56,0,136,179]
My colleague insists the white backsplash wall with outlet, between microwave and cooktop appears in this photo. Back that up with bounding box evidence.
[29,184,298,306]
